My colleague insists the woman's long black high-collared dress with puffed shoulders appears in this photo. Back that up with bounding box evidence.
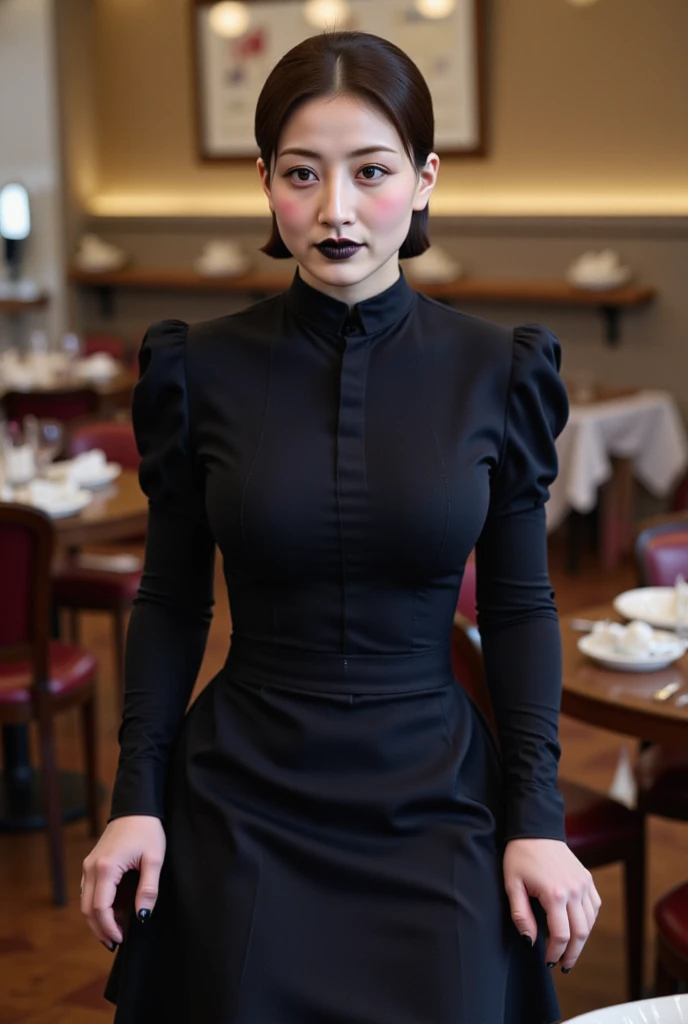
[108,272,567,1024]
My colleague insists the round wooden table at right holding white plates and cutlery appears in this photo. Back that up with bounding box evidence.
[561,604,688,748]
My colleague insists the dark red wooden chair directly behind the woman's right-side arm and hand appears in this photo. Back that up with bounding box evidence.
[450,614,645,999]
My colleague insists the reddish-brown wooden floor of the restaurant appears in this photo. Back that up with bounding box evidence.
[0,545,688,1024]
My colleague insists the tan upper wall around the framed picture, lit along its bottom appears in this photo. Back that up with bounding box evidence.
[75,0,688,216]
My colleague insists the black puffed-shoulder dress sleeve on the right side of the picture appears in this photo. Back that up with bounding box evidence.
[476,326,568,841]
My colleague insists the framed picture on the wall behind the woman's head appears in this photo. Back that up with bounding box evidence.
[190,0,485,161]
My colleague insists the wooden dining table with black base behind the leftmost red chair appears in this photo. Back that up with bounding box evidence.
[0,469,148,833]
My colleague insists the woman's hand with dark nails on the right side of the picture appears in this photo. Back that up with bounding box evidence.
[504,839,602,974]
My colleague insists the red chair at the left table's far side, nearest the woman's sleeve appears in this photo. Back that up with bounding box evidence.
[52,420,141,688]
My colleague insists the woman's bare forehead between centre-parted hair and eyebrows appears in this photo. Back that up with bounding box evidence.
[277,95,405,156]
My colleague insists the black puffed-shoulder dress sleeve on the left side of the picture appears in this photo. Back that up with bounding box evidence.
[111,321,215,820]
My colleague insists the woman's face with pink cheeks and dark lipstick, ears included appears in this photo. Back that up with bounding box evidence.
[258,95,439,305]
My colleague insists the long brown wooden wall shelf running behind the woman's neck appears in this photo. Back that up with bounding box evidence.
[69,267,657,345]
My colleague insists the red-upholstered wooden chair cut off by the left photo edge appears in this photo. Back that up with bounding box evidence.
[0,504,98,906]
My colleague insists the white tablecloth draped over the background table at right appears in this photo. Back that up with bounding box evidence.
[547,391,688,529]
